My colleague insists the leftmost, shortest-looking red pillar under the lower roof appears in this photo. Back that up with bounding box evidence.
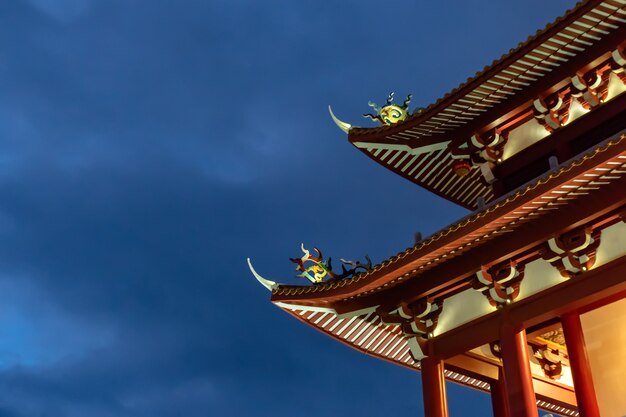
[420,357,448,417]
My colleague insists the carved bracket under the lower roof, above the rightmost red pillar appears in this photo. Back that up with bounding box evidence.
[541,228,600,279]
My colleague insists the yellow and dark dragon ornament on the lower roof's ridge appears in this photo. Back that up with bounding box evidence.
[289,243,372,284]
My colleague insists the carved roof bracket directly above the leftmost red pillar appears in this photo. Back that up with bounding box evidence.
[377,299,443,339]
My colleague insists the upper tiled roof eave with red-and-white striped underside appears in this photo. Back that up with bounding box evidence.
[349,0,626,209]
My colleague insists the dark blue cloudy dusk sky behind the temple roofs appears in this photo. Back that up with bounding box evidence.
[0,0,574,417]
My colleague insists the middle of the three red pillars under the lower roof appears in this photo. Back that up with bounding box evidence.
[500,318,539,417]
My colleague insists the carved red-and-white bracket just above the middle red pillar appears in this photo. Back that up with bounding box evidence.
[472,261,524,307]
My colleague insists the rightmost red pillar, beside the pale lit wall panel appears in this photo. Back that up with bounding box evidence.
[561,313,600,417]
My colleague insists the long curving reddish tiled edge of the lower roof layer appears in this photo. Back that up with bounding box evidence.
[272,132,626,306]
